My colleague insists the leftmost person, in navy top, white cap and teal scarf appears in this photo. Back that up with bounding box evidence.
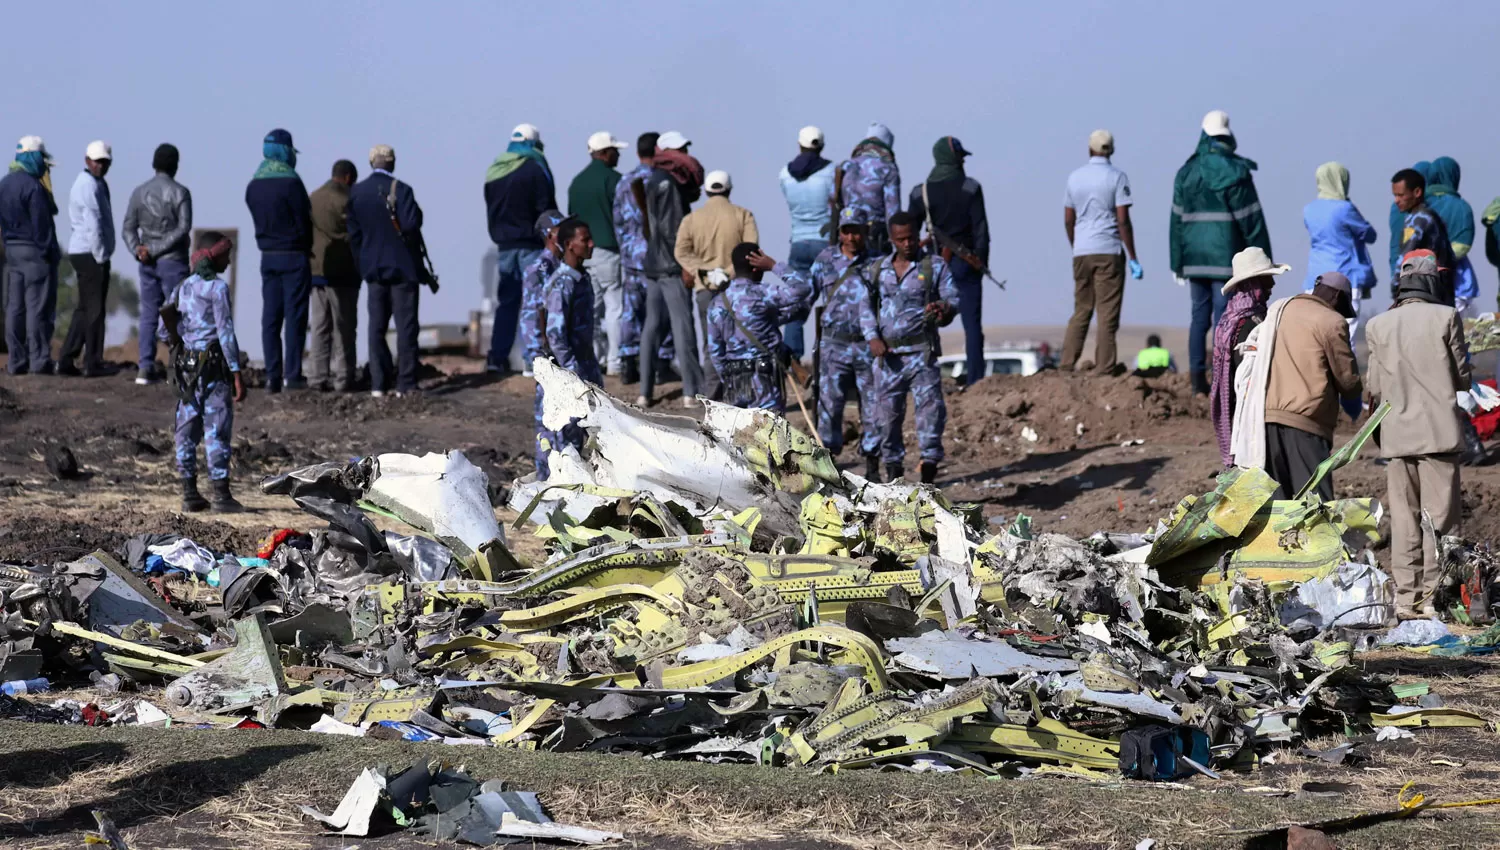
[0,136,62,375]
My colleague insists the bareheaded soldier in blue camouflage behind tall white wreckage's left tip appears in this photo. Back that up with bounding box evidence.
[536,219,605,480]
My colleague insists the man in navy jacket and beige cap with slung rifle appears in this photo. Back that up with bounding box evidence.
[348,144,428,399]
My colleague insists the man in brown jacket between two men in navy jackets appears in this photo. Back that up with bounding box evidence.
[308,159,360,393]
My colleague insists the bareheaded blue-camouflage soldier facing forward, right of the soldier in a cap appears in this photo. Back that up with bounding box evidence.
[864,213,959,484]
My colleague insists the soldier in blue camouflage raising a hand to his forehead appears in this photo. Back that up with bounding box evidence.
[708,241,813,412]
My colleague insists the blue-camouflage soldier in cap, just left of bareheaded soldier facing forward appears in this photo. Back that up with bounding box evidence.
[812,207,881,481]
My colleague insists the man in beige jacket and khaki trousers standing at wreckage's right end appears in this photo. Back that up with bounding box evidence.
[1365,249,1472,619]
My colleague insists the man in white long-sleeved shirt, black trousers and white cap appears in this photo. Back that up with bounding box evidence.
[57,141,114,378]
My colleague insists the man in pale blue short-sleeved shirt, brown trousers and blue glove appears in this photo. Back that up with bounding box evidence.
[1059,130,1143,372]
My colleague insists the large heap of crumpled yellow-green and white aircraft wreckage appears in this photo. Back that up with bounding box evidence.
[0,363,1500,778]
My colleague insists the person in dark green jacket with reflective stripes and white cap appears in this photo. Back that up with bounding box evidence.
[1172,109,1271,394]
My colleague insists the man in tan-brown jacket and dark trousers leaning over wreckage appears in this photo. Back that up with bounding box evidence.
[1266,271,1364,499]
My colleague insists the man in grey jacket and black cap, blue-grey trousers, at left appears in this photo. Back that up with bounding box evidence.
[122,144,192,385]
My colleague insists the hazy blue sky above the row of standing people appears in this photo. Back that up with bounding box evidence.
[14,0,1500,355]
